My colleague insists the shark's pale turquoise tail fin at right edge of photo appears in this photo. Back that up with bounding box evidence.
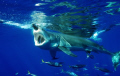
[112,51,120,71]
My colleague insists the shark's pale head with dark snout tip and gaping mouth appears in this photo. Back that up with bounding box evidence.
[32,24,50,46]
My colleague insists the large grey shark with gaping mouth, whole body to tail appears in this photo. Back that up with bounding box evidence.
[33,26,120,70]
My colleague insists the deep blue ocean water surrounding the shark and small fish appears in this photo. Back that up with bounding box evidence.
[0,0,120,76]
